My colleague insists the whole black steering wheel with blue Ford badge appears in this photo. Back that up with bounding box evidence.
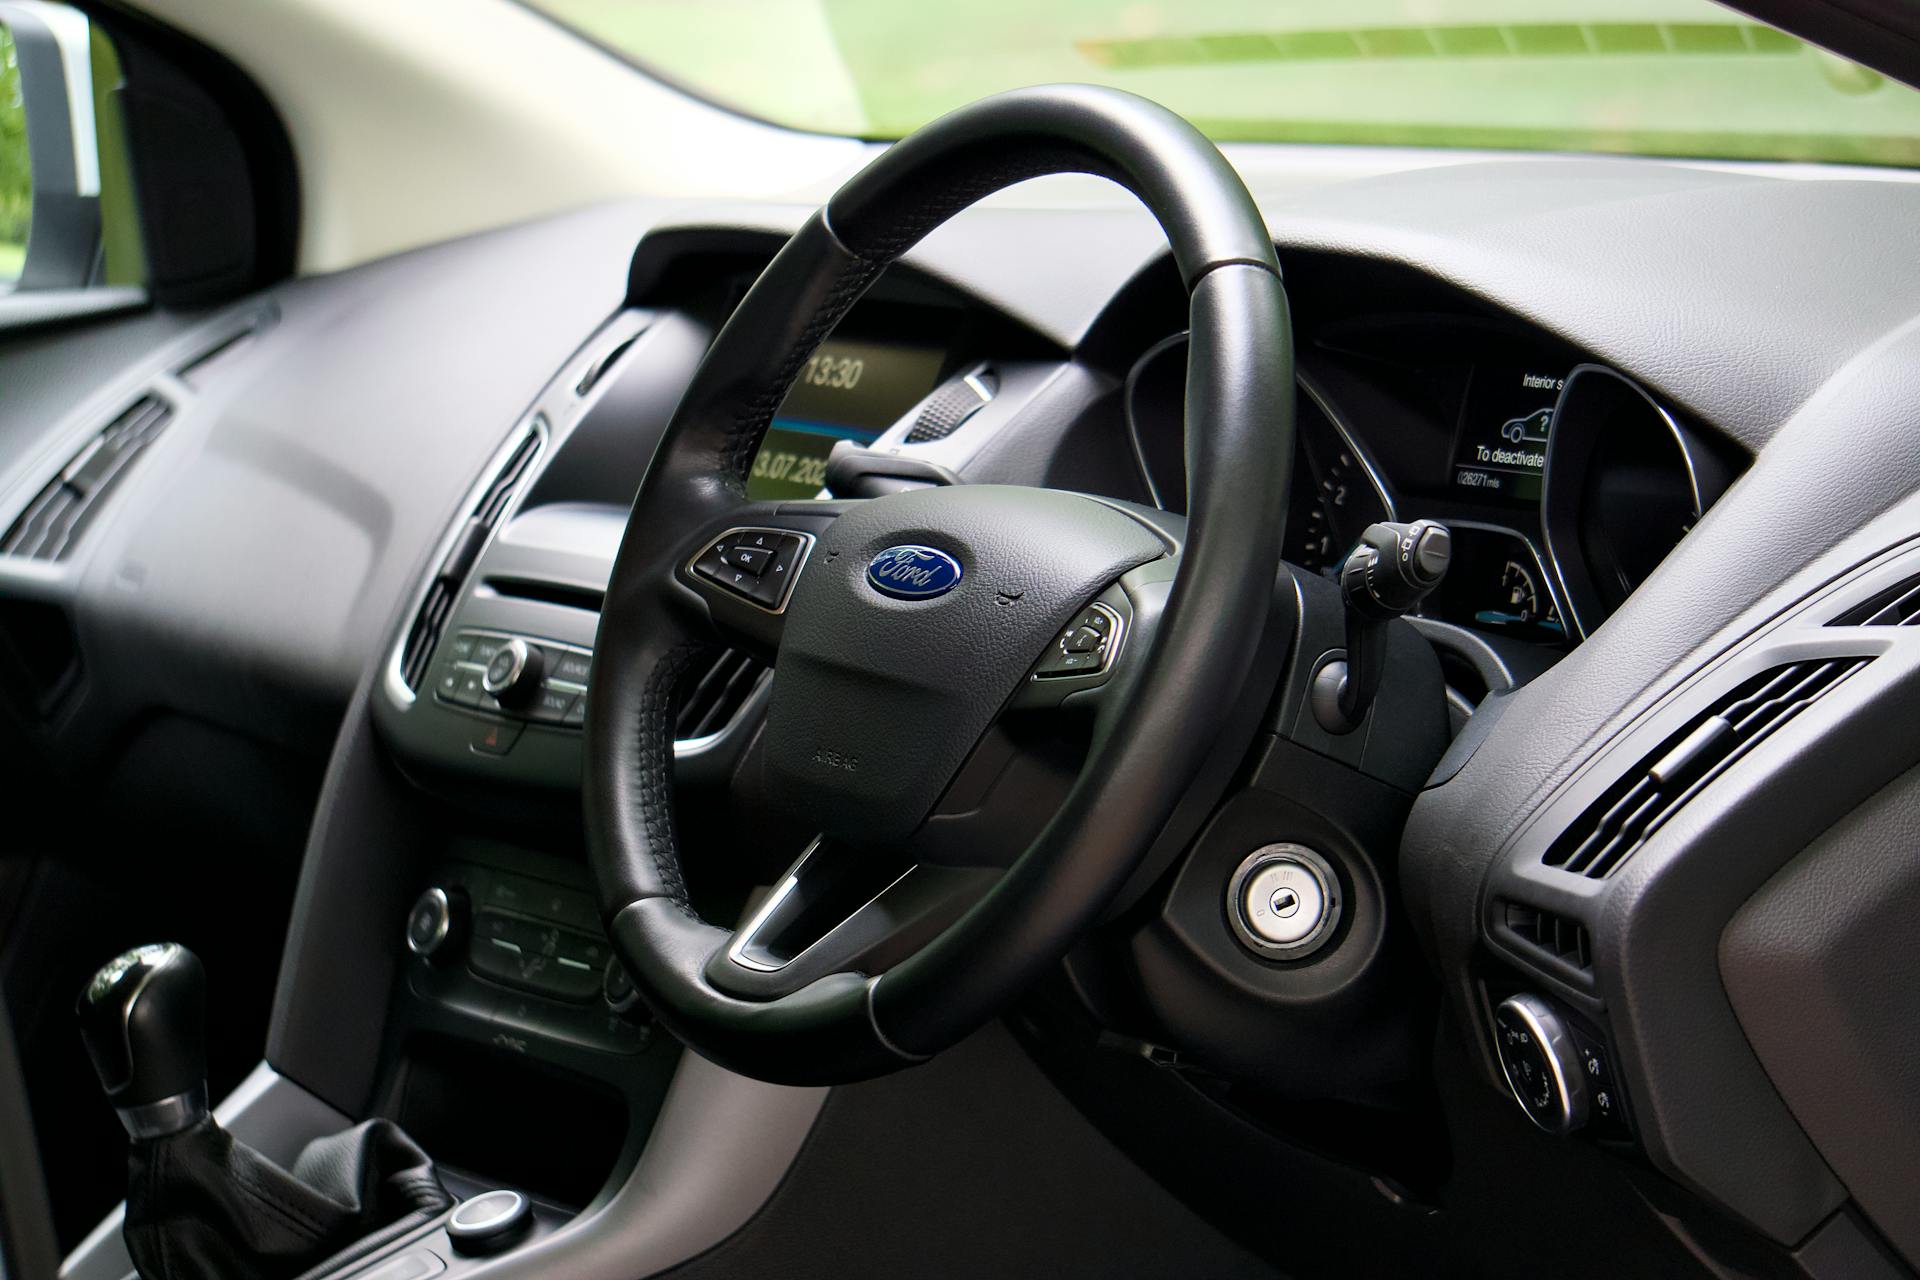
[584,86,1294,1084]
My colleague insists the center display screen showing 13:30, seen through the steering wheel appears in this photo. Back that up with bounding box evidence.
[747,338,947,501]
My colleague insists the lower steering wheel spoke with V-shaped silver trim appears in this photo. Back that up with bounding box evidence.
[707,837,996,1000]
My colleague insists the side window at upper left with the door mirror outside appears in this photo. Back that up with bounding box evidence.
[0,0,146,296]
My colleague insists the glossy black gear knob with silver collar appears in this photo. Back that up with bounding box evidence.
[77,942,207,1138]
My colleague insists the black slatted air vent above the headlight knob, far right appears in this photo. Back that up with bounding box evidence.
[1546,658,1870,879]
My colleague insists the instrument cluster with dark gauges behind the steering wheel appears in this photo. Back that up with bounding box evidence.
[1125,322,1736,649]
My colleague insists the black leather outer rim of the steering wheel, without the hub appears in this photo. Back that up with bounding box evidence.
[584,86,1294,1084]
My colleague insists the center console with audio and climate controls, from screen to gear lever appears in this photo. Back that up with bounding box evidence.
[165,257,1054,1280]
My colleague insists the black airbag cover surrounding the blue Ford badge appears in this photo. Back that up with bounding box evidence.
[764,486,1167,844]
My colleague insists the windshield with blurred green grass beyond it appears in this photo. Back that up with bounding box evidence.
[528,0,1920,165]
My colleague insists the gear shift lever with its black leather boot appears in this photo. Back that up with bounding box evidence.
[79,942,453,1280]
